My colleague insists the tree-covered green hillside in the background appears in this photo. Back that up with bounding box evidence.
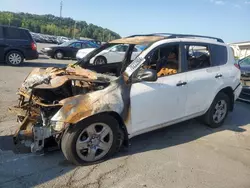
[0,11,120,41]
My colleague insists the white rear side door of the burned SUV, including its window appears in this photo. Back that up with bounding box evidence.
[184,43,224,116]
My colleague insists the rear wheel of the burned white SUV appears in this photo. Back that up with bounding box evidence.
[204,92,230,128]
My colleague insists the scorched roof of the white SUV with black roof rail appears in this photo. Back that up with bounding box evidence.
[109,33,224,45]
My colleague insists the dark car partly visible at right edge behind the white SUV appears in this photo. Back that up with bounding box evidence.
[238,56,250,102]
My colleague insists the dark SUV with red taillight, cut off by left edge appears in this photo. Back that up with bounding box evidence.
[0,25,38,66]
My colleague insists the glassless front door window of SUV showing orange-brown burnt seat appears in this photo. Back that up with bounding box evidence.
[144,45,180,77]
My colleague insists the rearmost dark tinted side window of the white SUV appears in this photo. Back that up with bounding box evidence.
[211,45,227,66]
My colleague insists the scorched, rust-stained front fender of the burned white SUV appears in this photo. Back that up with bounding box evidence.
[51,76,130,128]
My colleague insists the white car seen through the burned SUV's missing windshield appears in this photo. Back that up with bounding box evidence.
[76,44,142,65]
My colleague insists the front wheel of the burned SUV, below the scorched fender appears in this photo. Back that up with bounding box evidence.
[61,115,121,165]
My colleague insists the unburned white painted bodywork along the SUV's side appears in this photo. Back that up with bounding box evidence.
[126,39,241,137]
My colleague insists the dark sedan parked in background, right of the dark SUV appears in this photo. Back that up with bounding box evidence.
[41,40,99,59]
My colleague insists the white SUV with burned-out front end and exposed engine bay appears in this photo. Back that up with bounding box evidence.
[10,34,242,165]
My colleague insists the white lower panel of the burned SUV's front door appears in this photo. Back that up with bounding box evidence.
[130,73,187,132]
